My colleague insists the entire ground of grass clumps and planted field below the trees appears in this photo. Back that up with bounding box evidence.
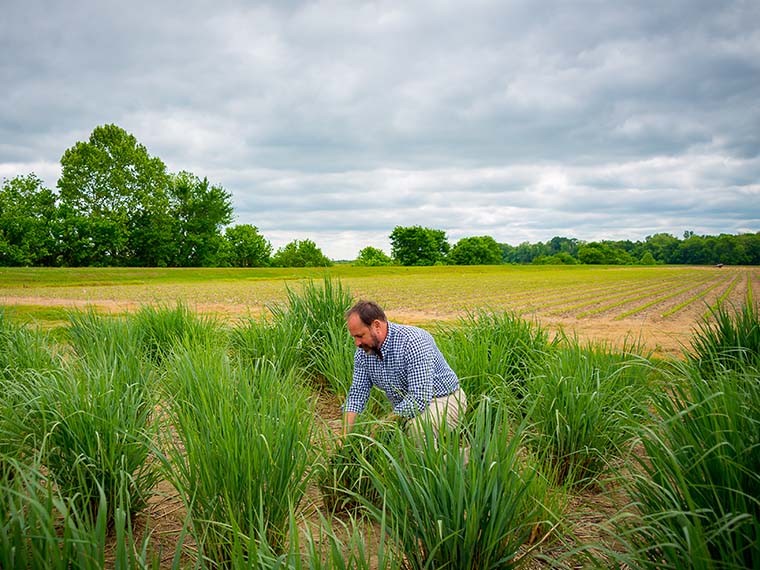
[0,267,760,570]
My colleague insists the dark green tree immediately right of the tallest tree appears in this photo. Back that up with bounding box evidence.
[168,171,233,267]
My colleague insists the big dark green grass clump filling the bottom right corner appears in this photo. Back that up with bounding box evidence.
[617,365,760,569]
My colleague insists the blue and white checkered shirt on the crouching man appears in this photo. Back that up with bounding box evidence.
[343,322,459,418]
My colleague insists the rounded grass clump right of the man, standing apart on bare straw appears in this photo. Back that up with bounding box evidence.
[523,339,653,486]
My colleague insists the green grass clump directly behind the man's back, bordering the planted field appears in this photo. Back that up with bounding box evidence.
[436,310,556,400]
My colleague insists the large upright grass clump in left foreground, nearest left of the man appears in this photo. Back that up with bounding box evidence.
[160,346,316,564]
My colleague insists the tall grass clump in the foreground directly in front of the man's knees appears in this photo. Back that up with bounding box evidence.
[366,399,556,569]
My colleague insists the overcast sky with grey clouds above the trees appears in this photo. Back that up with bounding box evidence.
[0,0,760,259]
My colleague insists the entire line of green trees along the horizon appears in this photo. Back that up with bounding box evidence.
[0,125,760,267]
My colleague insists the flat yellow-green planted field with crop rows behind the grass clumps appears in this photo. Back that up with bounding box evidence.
[0,265,760,355]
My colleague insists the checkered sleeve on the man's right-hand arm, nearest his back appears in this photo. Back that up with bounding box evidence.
[393,335,435,418]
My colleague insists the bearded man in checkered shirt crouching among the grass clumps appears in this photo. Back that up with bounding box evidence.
[343,301,467,440]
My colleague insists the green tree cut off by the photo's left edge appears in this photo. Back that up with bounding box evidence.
[0,174,57,266]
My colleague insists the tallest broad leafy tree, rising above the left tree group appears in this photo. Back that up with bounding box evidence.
[58,125,170,265]
